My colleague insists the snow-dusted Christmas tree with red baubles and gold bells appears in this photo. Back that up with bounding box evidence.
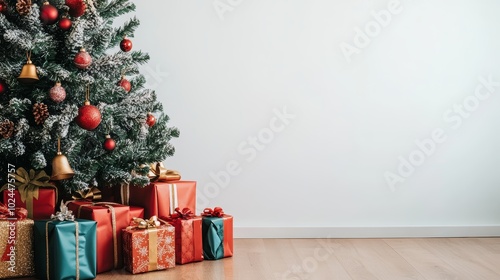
[0,0,179,192]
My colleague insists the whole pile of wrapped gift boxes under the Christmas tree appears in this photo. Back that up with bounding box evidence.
[0,167,233,279]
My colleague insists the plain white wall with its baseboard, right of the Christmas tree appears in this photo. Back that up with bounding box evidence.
[128,0,500,237]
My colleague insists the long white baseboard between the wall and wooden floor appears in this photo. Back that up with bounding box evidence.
[234,225,500,238]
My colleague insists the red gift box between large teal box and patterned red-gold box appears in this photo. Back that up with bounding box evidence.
[68,201,130,273]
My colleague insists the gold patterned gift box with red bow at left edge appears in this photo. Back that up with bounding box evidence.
[0,203,35,279]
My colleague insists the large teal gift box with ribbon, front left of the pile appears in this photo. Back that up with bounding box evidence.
[33,219,97,280]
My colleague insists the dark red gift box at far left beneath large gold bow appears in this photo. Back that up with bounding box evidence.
[3,186,57,220]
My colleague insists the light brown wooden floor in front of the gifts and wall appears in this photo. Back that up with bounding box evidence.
[28,238,500,280]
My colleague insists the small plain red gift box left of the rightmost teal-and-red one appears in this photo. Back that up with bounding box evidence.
[160,208,203,264]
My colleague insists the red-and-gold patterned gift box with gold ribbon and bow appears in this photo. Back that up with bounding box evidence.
[123,224,175,274]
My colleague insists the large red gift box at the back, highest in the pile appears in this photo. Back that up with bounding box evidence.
[129,181,196,217]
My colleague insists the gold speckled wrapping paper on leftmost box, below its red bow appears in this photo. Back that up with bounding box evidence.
[0,219,35,279]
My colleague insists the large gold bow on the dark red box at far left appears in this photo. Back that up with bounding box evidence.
[0,167,58,218]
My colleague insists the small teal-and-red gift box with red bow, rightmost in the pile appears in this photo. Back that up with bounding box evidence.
[201,207,233,260]
